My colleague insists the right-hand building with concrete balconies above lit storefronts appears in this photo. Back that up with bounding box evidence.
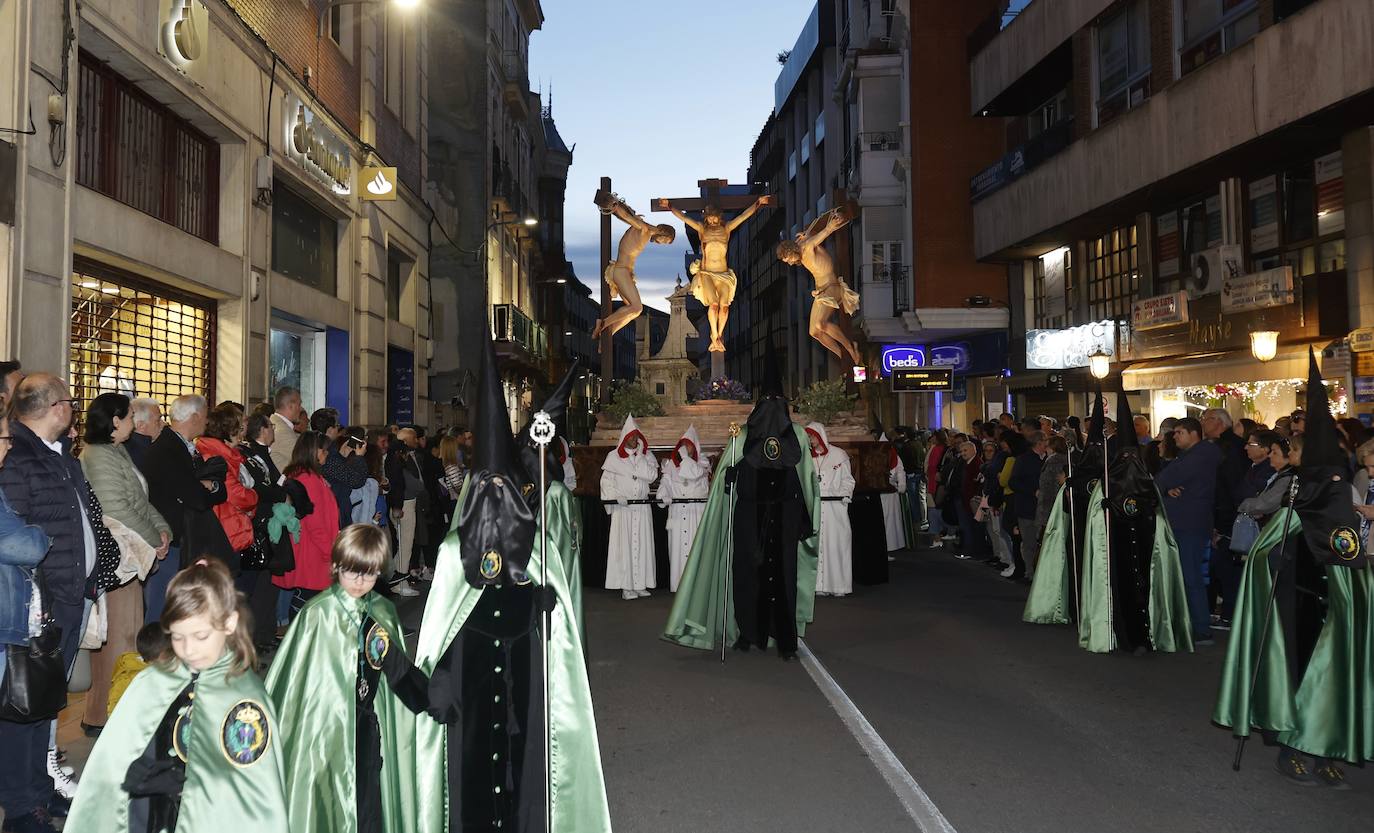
[969,0,1374,426]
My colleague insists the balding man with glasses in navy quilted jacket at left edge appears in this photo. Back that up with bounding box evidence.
[0,373,96,830]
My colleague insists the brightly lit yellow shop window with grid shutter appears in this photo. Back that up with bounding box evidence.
[71,260,216,412]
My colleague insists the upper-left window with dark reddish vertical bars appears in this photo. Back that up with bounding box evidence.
[76,52,220,243]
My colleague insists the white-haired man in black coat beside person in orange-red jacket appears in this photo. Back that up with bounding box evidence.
[142,396,239,576]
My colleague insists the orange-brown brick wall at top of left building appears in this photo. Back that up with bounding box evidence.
[225,0,368,135]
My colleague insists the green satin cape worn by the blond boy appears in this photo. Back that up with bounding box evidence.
[267,583,417,833]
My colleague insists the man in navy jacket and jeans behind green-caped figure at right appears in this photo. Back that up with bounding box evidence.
[1154,417,1221,645]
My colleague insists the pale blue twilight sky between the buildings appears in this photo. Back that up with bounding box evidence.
[529,0,815,311]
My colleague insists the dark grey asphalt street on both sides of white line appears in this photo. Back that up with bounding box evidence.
[585,550,1374,833]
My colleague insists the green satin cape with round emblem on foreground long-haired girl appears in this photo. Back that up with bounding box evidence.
[68,653,290,833]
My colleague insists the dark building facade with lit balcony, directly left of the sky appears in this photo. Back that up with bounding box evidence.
[429,0,544,426]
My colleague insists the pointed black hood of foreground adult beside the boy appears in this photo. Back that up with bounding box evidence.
[458,334,536,587]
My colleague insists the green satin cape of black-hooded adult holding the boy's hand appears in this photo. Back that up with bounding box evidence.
[414,485,610,833]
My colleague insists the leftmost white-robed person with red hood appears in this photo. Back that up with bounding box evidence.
[600,417,658,599]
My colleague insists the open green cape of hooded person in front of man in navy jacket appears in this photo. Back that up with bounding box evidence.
[1079,485,1193,653]
